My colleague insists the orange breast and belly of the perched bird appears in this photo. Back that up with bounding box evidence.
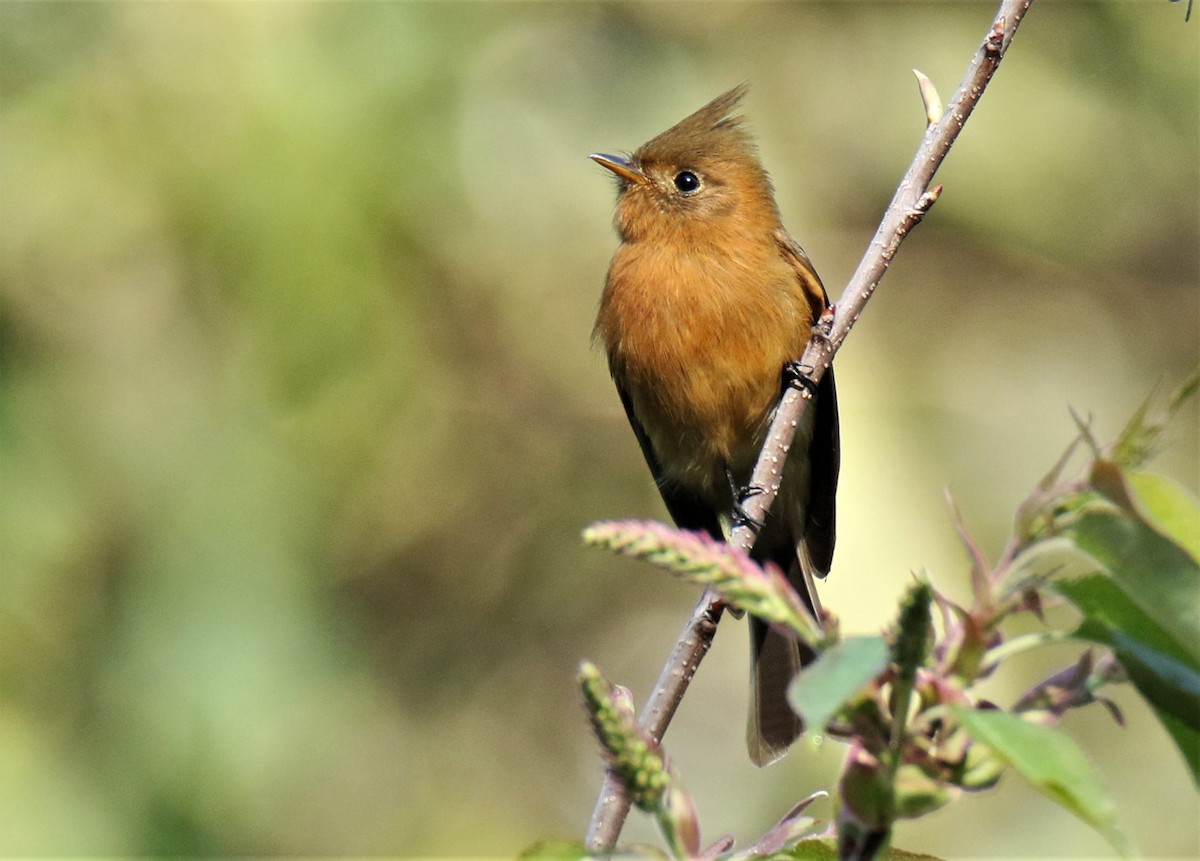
[596,243,812,504]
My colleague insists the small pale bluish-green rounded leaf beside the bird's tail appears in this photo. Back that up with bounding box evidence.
[787,636,888,733]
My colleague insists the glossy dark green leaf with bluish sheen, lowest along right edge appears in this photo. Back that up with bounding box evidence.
[1056,574,1200,785]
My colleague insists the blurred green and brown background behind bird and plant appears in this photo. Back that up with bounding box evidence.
[0,0,1200,857]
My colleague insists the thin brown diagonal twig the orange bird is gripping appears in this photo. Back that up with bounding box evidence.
[586,0,1033,853]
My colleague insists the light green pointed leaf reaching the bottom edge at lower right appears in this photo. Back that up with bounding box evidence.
[954,708,1136,857]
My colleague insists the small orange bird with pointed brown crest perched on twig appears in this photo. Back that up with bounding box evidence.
[592,85,839,765]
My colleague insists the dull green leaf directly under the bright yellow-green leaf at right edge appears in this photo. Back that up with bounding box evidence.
[1075,507,1200,666]
